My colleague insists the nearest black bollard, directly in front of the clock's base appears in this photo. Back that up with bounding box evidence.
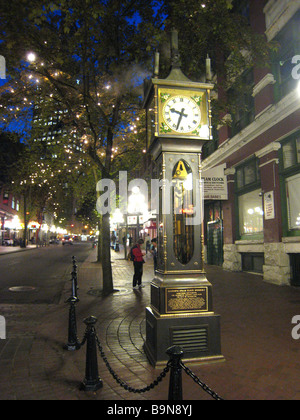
[167,346,184,401]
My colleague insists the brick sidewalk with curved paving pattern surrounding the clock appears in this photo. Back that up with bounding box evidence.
[0,246,300,401]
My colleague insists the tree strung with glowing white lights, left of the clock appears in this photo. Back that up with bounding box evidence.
[0,0,161,294]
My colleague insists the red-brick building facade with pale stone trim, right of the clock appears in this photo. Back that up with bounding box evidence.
[203,0,300,286]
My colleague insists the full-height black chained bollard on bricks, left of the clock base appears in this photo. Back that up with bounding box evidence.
[80,316,103,392]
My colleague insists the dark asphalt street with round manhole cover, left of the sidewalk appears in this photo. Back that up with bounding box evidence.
[0,243,92,304]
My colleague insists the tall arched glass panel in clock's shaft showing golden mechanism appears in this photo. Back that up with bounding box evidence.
[172,160,194,265]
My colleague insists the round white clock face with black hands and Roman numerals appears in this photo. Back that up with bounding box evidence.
[163,95,201,133]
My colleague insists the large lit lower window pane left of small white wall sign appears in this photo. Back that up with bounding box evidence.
[238,189,264,236]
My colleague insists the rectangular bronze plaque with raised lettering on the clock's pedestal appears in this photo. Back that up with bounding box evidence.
[166,287,208,313]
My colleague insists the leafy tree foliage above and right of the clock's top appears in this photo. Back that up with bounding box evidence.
[165,0,277,126]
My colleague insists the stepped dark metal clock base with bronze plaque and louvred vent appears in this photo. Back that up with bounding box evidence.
[144,278,225,367]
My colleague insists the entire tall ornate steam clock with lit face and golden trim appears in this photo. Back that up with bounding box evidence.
[144,31,223,366]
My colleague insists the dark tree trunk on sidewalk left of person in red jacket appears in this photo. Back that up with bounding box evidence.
[101,214,114,296]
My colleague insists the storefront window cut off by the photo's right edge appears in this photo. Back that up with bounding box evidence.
[286,174,300,230]
